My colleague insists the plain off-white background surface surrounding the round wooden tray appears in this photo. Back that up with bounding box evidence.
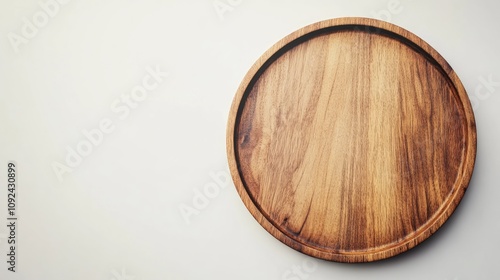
[0,0,500,280]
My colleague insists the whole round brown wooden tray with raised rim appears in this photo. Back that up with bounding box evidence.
[227,18,476,262]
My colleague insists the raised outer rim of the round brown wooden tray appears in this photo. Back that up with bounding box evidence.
[226,17,477,262]
